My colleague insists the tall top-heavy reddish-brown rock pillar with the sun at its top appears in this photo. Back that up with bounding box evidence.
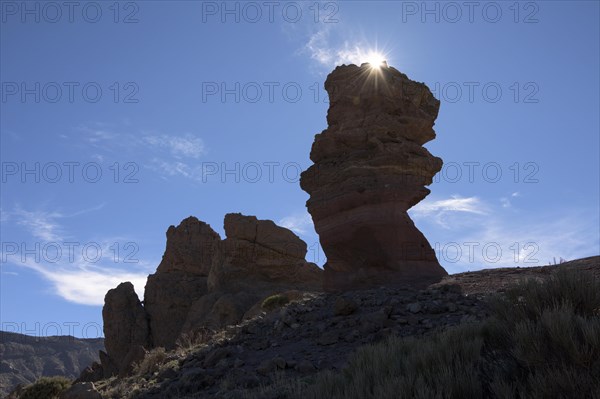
[300,64,446,290]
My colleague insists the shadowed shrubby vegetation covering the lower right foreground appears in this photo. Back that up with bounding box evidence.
[245,269,600,399]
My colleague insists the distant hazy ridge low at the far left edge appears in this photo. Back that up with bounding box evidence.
[0,331,104,397]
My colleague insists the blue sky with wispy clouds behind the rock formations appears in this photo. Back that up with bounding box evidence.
[0,1,600,337]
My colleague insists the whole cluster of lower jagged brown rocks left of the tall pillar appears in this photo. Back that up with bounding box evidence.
[101,214,322,379]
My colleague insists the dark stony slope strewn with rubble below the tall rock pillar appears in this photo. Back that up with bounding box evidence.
[91,256,600,398]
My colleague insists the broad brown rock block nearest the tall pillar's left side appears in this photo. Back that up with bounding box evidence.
[183,213,321,331]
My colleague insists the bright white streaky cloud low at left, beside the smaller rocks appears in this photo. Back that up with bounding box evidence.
[0,205,151,305]
